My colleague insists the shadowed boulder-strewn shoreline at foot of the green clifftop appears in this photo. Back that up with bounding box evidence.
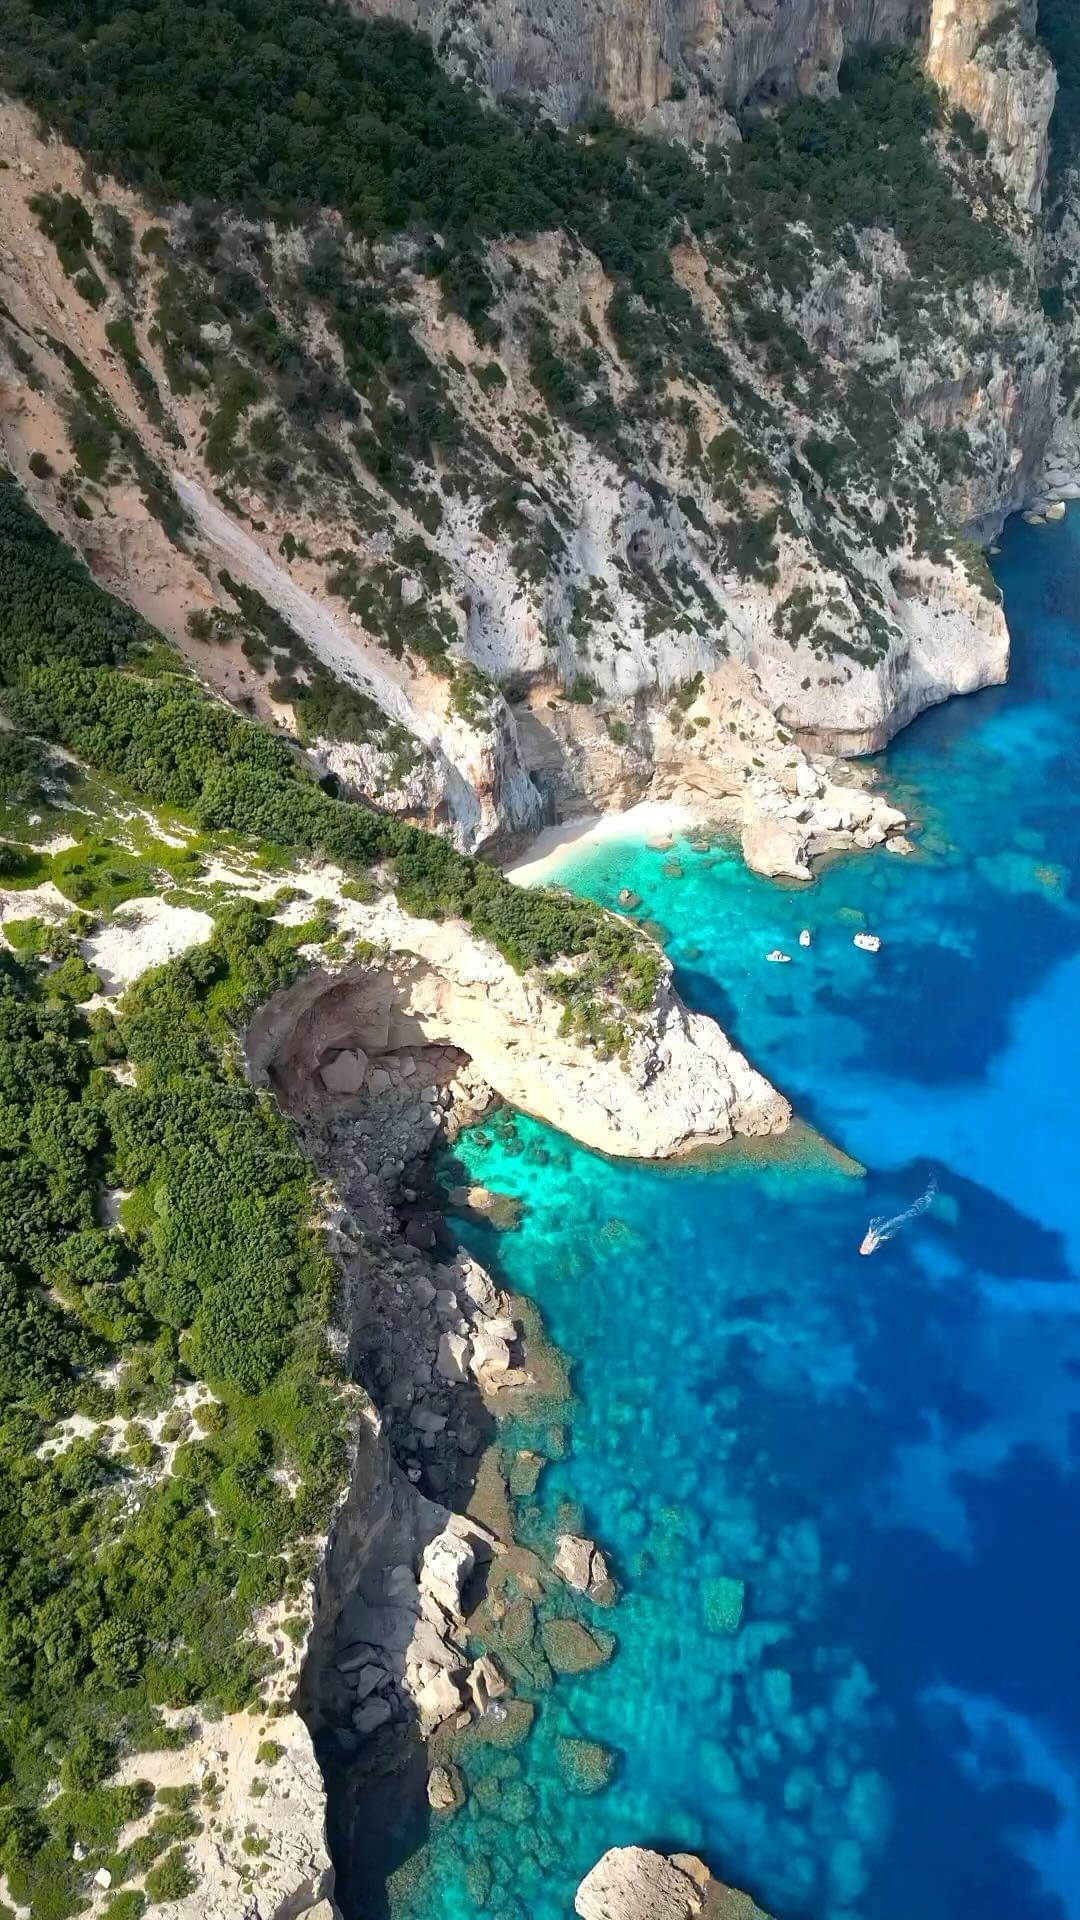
[286,1048,615,1914]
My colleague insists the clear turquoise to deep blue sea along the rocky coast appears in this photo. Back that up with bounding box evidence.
[386,511,1080,1920]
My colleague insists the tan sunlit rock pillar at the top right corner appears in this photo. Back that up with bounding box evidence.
[926,0,1057,213]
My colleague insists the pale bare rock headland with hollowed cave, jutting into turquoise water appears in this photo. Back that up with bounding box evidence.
[246,895,790,1152]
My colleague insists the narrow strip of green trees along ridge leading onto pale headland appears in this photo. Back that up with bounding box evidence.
[0,478,657,1043]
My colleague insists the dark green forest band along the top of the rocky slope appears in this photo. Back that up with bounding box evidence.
[0,0,1011,319]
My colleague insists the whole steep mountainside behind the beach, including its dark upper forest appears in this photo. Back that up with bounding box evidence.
[0,0,1057,847]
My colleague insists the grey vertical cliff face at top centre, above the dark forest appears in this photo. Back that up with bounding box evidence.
[359,0,926,140]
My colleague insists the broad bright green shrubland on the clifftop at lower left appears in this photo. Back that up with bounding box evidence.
[0,904,344,1920]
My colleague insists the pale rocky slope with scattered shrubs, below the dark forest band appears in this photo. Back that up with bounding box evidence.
[0,8,1057,847]
